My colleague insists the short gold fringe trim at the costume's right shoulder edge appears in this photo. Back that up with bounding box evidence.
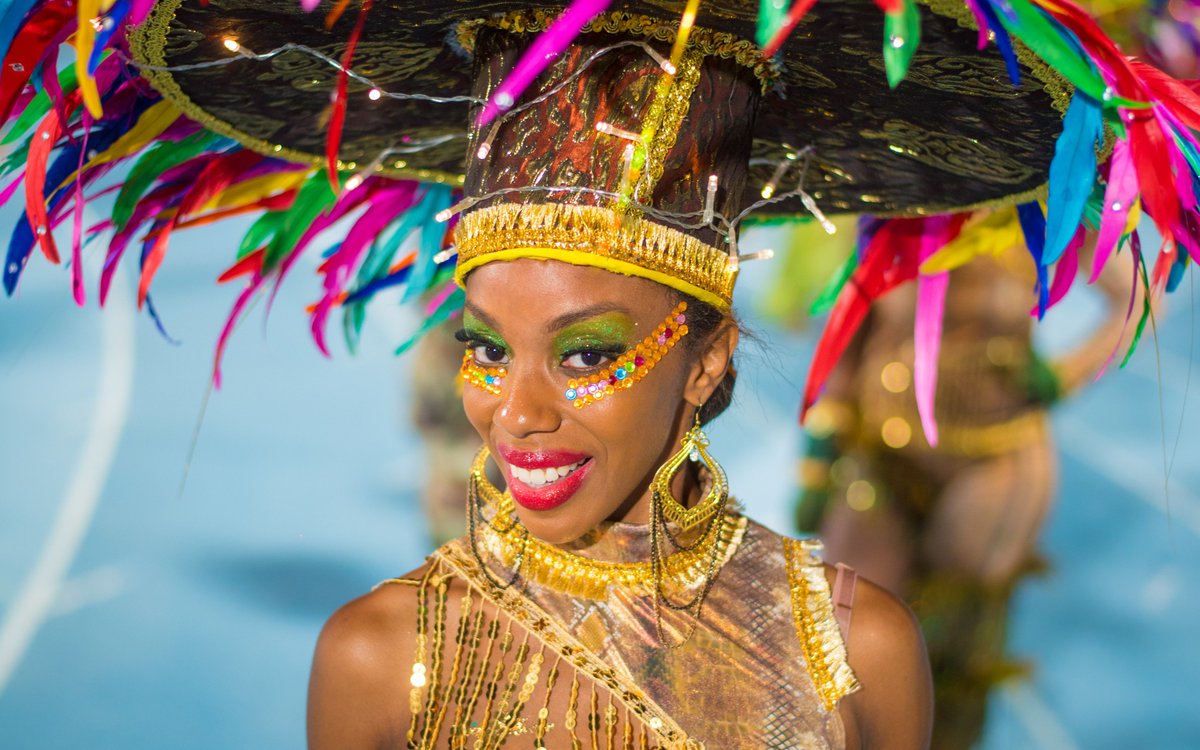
[784,539,860,712]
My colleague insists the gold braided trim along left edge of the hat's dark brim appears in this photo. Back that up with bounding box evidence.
[130,0,466,186]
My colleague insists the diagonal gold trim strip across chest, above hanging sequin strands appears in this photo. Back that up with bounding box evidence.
[433,542,697,750]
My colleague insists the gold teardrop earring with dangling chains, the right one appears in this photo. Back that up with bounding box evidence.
[650,407,730,648]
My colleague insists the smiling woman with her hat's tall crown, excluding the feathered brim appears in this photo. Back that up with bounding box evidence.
[302,16,931,750]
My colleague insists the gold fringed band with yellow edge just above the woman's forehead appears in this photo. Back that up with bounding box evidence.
[455,203,738,311]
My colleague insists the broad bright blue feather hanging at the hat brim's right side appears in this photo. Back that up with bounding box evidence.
[1042,91,1104,265]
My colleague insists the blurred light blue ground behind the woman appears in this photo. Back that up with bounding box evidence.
[0,213,1200,750]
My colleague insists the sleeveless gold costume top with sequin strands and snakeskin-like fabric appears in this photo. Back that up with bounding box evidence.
[395,512,858,750]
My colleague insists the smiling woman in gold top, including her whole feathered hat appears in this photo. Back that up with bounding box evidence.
[11,0,1200,750]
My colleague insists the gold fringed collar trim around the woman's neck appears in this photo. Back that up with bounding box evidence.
[470,448,748,600]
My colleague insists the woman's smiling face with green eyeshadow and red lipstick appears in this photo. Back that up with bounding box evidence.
[463,258,712,544]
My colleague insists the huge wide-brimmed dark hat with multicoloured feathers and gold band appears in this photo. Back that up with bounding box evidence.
[0,0,1200,396]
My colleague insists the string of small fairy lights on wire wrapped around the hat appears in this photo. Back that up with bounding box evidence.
[125,0,836,264]
